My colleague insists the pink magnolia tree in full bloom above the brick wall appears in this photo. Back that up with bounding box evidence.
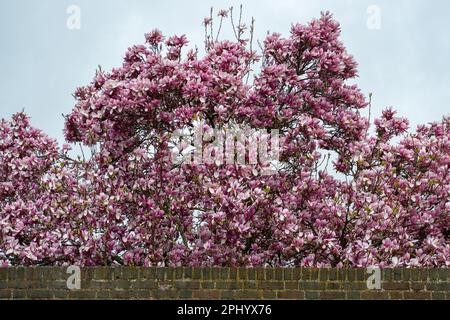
[0,10,450,267]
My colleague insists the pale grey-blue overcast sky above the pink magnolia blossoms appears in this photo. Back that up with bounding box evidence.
[0,0,450,142]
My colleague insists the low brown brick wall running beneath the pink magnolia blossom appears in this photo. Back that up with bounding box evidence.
[0,267,450,300]
